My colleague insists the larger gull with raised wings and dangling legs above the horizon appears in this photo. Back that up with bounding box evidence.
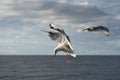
[42,24,76,63]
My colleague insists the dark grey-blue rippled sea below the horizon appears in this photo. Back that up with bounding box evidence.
[0,56,120,80]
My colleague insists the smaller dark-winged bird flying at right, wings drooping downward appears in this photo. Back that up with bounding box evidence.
[82,25,110,36]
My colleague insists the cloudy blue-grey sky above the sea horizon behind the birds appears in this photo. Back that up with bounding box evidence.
[0,0,120,55]
